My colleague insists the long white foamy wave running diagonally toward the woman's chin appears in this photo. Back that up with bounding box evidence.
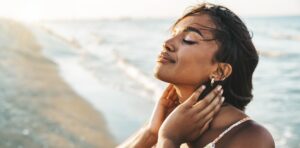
[42,26,161,101]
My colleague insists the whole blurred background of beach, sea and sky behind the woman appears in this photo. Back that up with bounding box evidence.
[0,0,300,148]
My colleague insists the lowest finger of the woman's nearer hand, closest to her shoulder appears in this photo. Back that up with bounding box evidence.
[196,97,224,124]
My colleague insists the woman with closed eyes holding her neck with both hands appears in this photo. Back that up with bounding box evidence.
[121,3,274,148]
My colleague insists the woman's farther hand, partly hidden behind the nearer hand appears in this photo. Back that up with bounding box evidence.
[148,84,179,137]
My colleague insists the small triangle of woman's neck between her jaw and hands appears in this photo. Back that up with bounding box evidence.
[174,85,199,103]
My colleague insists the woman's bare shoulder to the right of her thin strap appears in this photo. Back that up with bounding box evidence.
[226,120,275,148]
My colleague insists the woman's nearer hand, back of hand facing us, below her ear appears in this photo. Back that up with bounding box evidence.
[158,86,224,146]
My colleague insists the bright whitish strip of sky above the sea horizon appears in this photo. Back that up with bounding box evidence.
[0,0,300,21]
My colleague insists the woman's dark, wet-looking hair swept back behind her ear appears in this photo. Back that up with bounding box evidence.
[173,3,258,110]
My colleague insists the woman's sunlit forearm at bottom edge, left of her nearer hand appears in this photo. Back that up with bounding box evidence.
[118,127,157,148]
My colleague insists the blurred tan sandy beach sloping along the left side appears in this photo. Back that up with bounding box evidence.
[0,19,116,148]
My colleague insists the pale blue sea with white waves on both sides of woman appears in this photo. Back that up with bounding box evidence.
[31,16,300,148]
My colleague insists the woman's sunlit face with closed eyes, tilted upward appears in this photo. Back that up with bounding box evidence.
[154,14,218,85]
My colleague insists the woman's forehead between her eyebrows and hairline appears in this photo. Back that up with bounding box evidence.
[173,14,216,30]
